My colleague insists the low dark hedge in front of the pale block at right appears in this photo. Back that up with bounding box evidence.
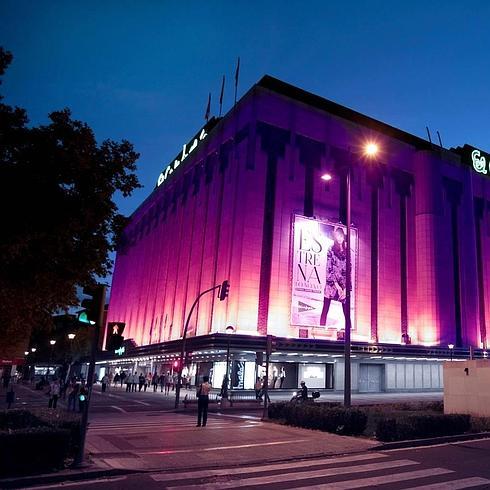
[376,414,471,442]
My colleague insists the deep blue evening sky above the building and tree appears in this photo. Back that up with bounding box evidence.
[0,0,490,220]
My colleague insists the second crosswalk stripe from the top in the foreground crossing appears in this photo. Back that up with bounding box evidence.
[167,459,419,490]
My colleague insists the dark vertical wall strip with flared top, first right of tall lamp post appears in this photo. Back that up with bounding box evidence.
[367,164,383,342]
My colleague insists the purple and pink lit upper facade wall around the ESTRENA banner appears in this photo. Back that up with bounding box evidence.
[108,76,490,347]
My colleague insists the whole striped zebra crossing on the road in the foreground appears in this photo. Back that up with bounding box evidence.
[151,453,490,490]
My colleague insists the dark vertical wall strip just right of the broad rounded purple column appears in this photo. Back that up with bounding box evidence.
[443,178,463,347]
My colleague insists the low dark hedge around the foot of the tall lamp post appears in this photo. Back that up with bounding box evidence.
[269,403,367,435]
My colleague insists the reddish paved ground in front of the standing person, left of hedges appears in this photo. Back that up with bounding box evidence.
[86,413,379,471]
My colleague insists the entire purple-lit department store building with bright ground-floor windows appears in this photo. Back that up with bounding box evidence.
[99,76,490,392]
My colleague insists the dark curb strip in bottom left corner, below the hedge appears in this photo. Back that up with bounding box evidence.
[0,468,143,488]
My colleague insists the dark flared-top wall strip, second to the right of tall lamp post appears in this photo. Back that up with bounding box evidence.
[392,169,413,339]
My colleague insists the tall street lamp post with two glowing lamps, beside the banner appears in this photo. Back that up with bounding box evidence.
[321,142,378,407]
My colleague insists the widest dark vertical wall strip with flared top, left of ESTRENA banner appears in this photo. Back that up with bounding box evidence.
[257,122,290,335]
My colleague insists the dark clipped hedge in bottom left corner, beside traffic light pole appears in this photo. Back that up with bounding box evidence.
[0,427,69,476]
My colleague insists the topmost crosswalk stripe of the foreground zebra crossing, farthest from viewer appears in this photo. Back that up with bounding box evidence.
[151,453,387,481]
